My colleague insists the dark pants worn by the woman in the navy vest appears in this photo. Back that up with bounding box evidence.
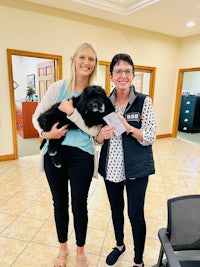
[105,177,148,264]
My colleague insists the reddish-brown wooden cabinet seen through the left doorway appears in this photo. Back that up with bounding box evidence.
[16,102,39,138]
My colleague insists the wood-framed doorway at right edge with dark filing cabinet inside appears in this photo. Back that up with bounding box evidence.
[173,68,200,143]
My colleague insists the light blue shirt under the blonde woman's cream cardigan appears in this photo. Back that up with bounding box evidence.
[44,81,94,155]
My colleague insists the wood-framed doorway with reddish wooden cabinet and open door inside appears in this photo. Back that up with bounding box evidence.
[7,49,62,159]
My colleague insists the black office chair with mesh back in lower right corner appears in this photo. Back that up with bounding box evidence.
[157,195,200,267]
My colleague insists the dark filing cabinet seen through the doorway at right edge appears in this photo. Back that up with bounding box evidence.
[178,95,200,133]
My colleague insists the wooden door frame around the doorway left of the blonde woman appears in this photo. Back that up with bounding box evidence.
[7,49,62,159]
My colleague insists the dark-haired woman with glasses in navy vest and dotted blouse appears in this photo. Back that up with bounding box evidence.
[96,54,156,267]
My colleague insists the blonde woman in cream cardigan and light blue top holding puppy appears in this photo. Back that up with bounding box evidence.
[33,43,100,267]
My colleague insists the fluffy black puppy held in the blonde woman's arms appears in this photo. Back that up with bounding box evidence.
[38,85,114,168]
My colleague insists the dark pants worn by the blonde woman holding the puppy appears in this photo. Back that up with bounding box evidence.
[44,146,94,247]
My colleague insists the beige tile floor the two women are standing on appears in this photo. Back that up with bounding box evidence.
[0,138,200,267]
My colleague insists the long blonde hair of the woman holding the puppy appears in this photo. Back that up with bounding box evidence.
[68,43,98,97]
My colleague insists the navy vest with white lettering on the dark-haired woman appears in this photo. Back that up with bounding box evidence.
[99,88,155,179]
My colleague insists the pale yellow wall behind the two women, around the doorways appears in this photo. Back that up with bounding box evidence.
[0,0,200,156]
